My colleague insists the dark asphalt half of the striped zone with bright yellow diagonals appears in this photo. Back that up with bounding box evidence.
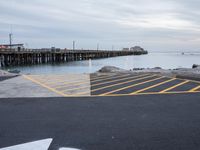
[91,73,200,96]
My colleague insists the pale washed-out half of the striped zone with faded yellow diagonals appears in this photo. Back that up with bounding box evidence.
[24,74,90,97]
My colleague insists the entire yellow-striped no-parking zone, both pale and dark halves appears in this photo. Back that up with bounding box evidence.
[24,73,200,97]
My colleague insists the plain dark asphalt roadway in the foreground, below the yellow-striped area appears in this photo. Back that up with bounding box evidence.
[0,93,200,150]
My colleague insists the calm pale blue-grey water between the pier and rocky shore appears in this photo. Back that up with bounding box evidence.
[3,53,200,74]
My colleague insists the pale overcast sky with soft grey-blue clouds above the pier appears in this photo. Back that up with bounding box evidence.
[0,0,200,52]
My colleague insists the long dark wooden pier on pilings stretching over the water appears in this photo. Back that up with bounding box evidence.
[0,49,147,67]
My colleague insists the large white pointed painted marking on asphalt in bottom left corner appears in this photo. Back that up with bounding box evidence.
[0,139,53,150]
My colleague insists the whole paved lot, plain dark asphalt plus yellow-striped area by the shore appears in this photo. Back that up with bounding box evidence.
[0,73,200,150]
